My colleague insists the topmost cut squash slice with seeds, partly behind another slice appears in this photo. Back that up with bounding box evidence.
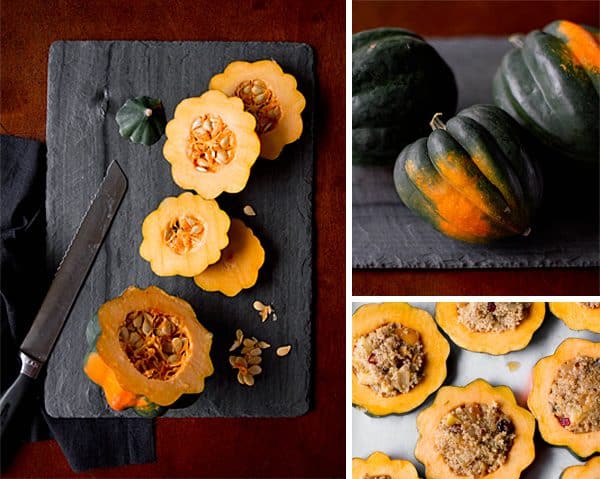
[208,60,306,160]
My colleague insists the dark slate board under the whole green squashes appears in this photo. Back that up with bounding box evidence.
[352,38,600,268]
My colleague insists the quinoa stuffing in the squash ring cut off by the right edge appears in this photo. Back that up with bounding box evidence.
[548,356,600,433]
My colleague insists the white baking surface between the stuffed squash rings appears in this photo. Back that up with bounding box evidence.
[352,303,600,479]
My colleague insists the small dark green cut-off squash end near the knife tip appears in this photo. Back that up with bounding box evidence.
[116,96,167,146]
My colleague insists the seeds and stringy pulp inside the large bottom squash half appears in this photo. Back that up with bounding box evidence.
[119,310,189,381]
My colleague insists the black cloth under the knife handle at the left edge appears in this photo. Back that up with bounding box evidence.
[0,135,156,472]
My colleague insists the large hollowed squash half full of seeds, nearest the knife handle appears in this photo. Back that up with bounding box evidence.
[84,286,213,408]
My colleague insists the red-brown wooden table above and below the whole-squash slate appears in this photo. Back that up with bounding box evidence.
[352,1,600,295]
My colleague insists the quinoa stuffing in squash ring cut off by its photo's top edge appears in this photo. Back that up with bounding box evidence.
[456,303,531,333]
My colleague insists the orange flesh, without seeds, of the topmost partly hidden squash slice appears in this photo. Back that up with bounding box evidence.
[209,60,306,160]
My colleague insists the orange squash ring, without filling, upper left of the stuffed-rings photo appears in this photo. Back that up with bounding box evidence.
[352,303,450,417]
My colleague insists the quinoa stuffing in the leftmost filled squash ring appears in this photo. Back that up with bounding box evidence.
[352,323,425,397]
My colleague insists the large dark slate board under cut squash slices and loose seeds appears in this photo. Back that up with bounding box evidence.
[45,41,315,417]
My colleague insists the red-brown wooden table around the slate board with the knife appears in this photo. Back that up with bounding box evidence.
[0,0,345,477]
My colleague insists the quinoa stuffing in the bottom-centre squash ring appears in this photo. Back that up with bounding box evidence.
[434,402,516,478]
